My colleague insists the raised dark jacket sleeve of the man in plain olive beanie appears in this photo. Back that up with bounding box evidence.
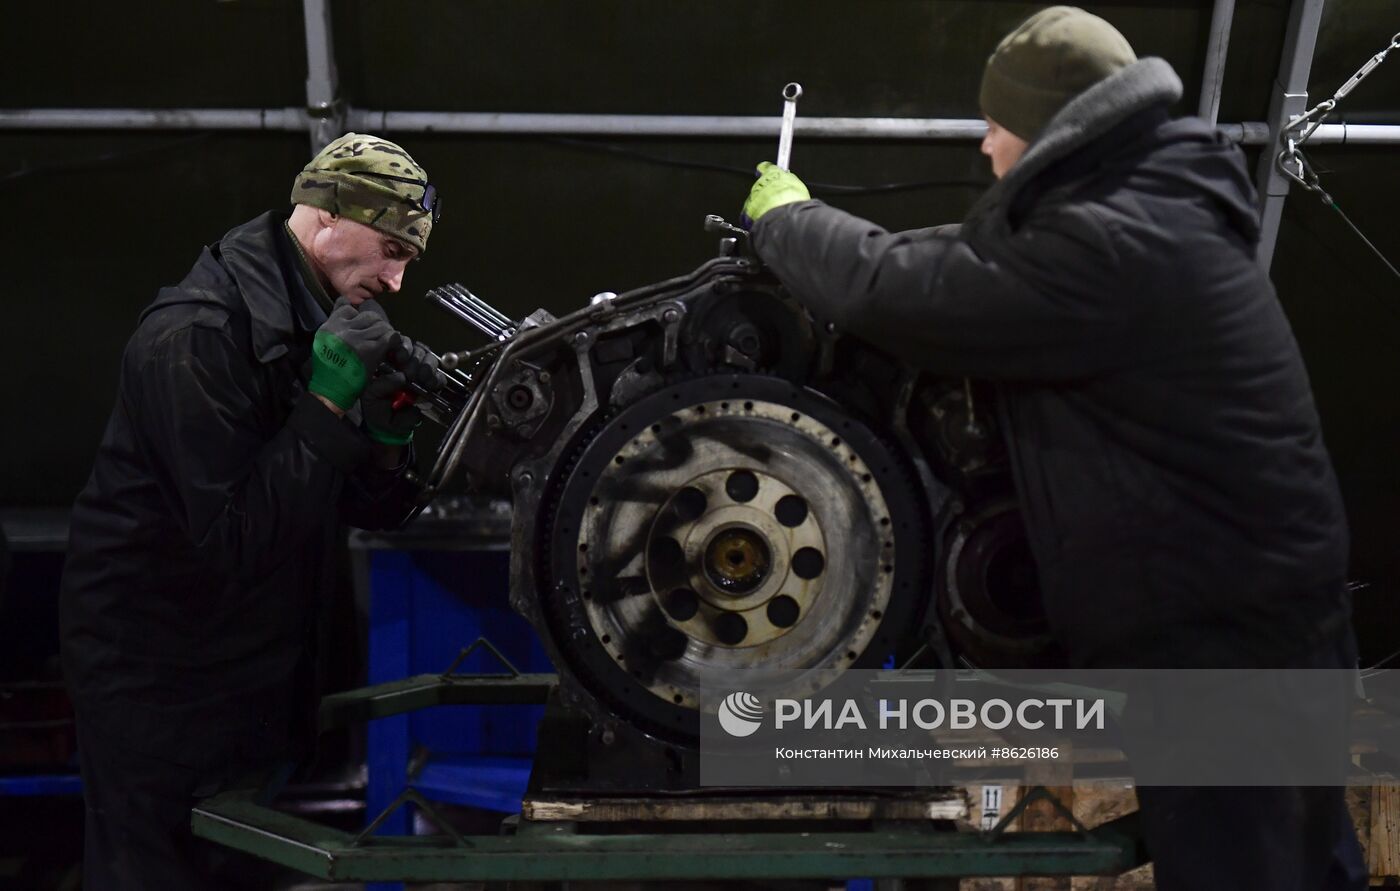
[753,202,1137,380]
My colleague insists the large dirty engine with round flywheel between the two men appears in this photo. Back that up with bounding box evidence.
[424,221,1054,789]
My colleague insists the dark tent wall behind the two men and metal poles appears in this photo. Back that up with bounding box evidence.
[0,0,1400,661]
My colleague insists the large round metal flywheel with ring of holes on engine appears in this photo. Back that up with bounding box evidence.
[540,375,927,739]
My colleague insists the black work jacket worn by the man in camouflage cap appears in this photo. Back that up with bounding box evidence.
[60,213,409,766]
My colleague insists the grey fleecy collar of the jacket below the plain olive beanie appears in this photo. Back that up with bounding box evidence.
[966,59,1182,224]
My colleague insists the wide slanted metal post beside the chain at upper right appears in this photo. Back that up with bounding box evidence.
[1256,0,1326,270]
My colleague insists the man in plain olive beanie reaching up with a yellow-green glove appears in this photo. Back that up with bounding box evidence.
[745,7,1366,891]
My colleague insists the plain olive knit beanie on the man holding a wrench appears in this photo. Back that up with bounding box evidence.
[979,6,1137,141]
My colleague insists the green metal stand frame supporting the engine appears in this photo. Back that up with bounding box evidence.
[193,640,1147,883]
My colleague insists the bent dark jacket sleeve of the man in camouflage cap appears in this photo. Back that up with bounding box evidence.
[129,325,370,581]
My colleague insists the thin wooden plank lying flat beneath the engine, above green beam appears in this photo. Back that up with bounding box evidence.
[521,790,969,822]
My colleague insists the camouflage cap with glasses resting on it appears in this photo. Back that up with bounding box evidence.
[291,133,437,255]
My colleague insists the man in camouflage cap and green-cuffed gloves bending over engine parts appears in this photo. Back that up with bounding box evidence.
[60,133,441,891]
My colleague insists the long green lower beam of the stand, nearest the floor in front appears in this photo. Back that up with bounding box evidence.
[193,793,1142,881]
